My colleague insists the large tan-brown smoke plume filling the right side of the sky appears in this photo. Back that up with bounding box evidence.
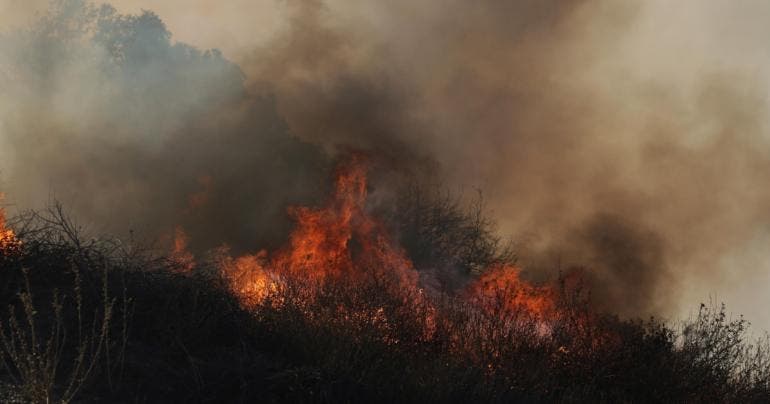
[243,1,769,321]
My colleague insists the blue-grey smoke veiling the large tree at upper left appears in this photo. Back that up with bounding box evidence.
[0,0,329,250]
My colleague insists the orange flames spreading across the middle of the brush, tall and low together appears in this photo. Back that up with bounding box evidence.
[164,155,584,356]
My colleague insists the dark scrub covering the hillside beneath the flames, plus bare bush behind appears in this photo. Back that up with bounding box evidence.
[0,200,770,402]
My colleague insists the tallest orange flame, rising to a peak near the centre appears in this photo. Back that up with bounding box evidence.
[221,155,417,302]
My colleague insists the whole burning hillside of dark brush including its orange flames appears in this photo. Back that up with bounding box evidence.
[0,157,770,402]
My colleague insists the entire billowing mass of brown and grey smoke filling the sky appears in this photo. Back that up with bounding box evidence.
[0,0,770,325]
